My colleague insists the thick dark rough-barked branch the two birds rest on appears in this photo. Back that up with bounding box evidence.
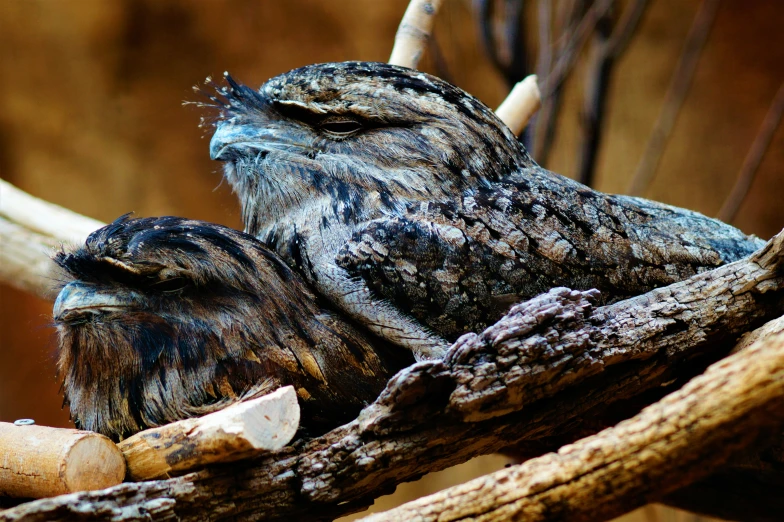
[0,228,784,521]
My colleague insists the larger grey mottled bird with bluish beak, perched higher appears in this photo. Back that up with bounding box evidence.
[204,62,763,360]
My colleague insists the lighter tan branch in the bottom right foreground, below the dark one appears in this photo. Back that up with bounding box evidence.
[362,333,784,522]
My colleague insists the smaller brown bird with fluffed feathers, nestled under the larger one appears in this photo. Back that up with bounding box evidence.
[53,215,413,440]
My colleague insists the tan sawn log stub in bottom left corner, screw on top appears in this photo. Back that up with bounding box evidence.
[0,422,125,498]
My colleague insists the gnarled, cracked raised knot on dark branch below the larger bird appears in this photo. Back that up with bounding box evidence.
[359,288,601,428]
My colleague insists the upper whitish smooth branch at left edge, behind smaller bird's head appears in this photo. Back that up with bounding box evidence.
[0,179,104,244]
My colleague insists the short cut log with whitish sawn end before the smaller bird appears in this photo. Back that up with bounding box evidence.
[119,386,300,480]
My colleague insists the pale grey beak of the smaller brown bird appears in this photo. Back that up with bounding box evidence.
[52,281,138,322]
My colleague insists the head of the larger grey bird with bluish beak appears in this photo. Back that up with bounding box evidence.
[210,62,531,233]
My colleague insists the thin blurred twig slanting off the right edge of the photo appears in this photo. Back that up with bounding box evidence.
[717,84,784,223]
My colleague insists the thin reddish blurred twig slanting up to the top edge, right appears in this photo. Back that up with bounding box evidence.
[627,0,720,196]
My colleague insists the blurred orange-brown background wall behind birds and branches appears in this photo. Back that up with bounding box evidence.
[0,0,784,520]
